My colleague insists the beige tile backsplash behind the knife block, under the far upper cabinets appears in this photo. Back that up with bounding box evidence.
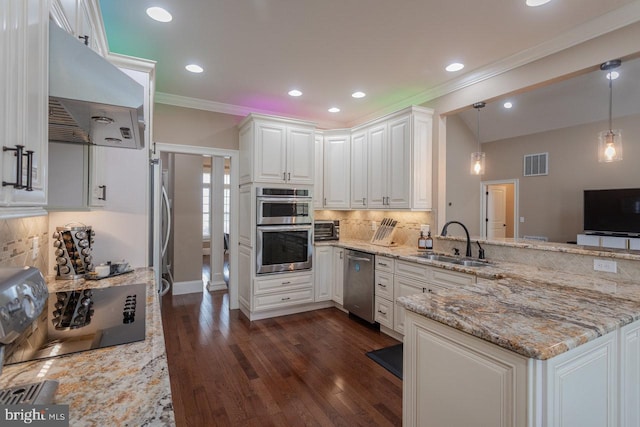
[314,210,433,246]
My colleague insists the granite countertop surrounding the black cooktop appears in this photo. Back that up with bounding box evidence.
[0,268,175,427]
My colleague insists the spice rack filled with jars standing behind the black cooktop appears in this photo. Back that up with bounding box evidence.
[53,224,95,280]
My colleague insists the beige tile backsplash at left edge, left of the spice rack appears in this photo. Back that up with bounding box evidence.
[0,215,51,276]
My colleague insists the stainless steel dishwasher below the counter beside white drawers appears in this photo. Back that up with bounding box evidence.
[343,249,375,323]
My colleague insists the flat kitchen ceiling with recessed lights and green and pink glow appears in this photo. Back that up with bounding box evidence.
[100,0,638,127]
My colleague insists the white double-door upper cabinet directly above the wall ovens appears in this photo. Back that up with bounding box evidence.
[240,114,315,185]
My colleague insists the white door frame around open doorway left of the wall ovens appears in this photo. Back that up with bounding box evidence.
[151,142,240,310]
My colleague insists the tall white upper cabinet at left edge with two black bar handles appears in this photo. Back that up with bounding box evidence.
[0,0,49,216]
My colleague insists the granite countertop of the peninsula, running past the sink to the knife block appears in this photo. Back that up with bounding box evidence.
[318,240,640,359]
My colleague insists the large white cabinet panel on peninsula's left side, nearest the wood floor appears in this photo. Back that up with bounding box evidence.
[402,313,528,427]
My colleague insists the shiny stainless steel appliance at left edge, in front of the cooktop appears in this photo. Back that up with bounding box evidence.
[0,267,49,344]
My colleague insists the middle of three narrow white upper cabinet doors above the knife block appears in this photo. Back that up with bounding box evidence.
[367,123,388,209]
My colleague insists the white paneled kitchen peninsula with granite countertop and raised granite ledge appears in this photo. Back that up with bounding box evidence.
[318,237,640,427]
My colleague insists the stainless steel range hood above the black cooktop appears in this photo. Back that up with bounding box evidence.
[49,23,145,149]
